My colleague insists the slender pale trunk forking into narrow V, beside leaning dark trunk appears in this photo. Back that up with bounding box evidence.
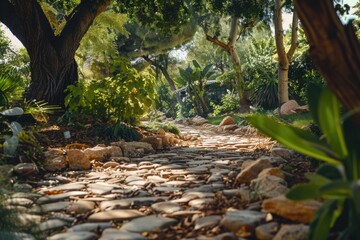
[274,0,299,105]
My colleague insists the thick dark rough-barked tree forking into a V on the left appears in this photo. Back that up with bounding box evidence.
[0,0,110,106]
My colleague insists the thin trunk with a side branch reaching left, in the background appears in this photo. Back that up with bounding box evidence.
[206,16,250,112]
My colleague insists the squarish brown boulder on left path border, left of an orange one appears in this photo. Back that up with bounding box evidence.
[43,148,67,172]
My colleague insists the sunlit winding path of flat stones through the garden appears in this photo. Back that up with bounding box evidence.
[1,123,316,240]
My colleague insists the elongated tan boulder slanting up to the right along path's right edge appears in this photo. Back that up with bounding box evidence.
[236,158,272,185]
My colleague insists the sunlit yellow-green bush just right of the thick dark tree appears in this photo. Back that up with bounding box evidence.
[65,58,156,123]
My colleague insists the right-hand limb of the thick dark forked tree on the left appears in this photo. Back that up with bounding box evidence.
[58,0,111,56]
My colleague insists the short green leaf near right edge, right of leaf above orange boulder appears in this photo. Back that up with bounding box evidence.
[319,180,350,199]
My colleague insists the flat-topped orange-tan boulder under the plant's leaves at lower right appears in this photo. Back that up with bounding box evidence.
[262,196,321,224]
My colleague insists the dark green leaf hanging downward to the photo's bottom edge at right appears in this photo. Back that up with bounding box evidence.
[309,199,338,240]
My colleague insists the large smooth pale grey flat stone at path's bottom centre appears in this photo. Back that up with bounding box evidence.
[120,215,178,232]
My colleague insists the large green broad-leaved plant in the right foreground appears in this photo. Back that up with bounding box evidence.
[246,87,360,240]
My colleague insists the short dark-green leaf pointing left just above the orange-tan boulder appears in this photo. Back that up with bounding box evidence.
[286,183,320,200]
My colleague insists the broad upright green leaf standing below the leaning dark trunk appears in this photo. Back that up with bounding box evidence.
[317,88,348,159]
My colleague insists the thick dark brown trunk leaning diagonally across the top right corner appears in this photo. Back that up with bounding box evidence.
[295,0,360,126]
